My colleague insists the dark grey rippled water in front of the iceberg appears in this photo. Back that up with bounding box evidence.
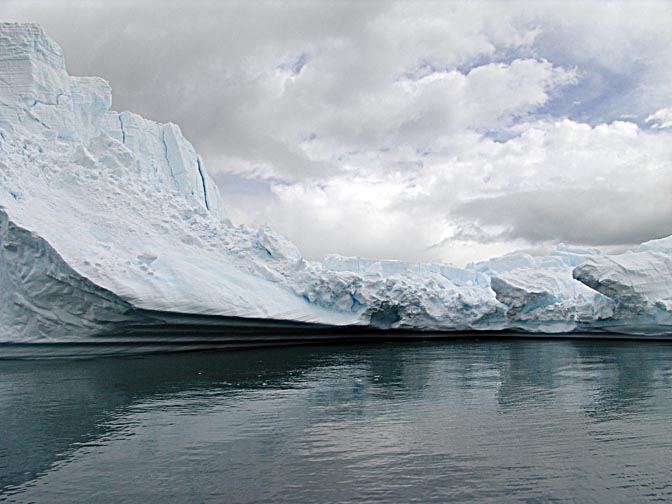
[0,340,672,503]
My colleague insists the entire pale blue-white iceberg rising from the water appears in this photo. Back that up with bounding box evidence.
[0,23,672,343]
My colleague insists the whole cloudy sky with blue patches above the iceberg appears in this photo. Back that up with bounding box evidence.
[5,0,672,265]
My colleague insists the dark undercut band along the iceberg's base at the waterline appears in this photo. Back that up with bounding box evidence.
[5,310,672,359]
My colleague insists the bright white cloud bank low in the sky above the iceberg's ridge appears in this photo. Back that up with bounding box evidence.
[236,120,672,263]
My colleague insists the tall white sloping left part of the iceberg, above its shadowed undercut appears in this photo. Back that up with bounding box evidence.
[0,24,357,340]
